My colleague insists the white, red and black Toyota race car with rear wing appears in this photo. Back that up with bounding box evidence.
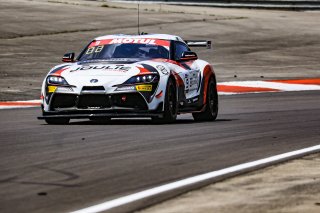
[38,34,218,124]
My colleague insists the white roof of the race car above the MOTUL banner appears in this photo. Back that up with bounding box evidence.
[94,34,185,43]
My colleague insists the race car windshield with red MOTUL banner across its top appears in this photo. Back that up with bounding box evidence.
[79,38,170,61]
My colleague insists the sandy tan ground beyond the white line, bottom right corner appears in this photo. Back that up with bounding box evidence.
[137,154,320,213]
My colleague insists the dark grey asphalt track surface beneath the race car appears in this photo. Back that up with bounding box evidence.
[0,91,320,212]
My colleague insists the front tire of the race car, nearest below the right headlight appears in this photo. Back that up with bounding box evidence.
[152,78,178,124]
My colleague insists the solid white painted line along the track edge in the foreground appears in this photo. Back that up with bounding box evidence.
[72,144,320,213]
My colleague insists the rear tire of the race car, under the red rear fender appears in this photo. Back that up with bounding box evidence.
[192,78,219,121]
